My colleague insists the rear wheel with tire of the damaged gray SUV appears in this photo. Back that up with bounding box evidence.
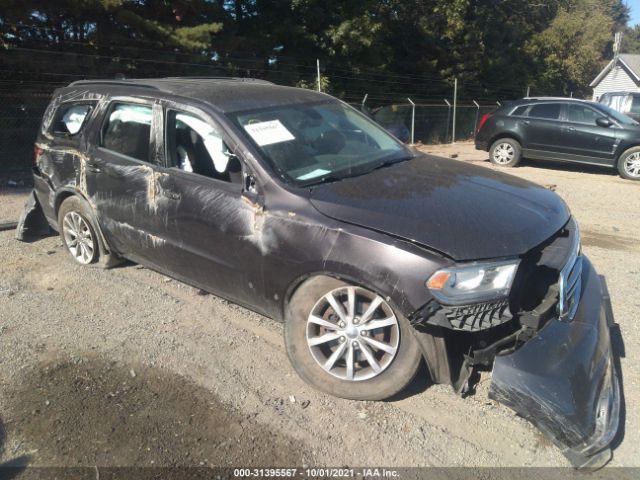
[58,197,100,265]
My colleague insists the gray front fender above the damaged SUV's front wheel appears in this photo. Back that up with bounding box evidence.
[262,211,448,318]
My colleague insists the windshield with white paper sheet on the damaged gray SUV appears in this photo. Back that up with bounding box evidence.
[232,102,412,186]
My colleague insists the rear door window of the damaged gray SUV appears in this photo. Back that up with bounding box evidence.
[101,103,152,162]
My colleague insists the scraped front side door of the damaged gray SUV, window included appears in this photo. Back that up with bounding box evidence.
[151,108,268,305]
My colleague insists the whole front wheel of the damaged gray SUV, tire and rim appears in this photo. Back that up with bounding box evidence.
[284,276,422,400]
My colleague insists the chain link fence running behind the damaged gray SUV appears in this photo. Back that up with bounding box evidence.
[0,49,522,172]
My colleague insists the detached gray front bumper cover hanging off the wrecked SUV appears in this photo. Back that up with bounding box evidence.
[489,258,620,468]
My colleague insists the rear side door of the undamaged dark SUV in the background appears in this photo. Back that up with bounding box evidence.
[520,102,563,158]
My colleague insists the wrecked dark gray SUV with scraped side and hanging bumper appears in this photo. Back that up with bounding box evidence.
[18,78,620,466]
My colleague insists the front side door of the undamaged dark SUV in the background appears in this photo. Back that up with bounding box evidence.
[562,103,617,165]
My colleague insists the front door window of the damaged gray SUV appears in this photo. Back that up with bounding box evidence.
[166,110,242,184]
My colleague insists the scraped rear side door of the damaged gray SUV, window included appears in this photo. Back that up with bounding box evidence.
[84,98,170,261]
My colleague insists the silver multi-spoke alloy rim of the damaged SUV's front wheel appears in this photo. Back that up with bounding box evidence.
[306,286,400,381]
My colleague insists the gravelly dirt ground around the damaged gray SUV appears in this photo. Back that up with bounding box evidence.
[0,143,640,467]
